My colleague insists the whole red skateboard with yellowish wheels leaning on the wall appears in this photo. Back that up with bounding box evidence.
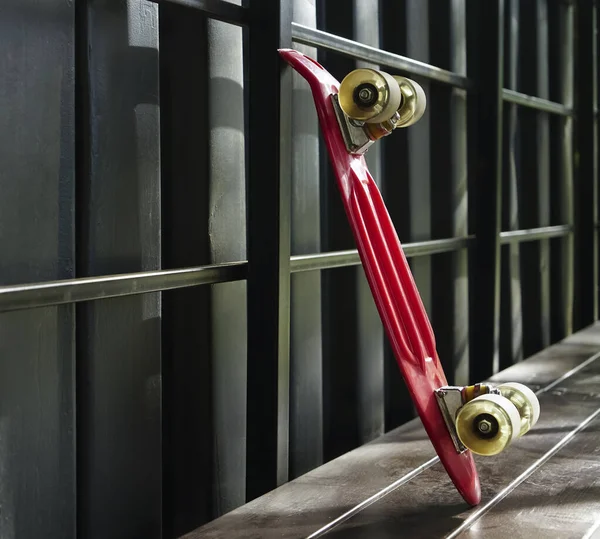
[279,49,539,505]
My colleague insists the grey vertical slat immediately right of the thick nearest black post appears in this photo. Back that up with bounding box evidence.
[290,0,323,478]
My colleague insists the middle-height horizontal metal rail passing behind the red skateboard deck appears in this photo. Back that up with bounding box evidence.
[291,236,474,273]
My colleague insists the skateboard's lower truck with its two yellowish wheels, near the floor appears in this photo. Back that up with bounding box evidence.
[434,382,540,455]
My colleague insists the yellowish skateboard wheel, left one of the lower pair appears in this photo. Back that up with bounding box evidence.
[456,394,521,456]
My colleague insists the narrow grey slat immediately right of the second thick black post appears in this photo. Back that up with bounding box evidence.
[500,0,523,367]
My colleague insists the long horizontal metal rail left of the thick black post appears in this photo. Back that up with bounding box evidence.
[0,262,248,312]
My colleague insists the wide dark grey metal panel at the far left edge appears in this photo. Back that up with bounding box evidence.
[0,0,76,539]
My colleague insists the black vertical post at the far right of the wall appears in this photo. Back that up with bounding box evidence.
[574,0,598,330]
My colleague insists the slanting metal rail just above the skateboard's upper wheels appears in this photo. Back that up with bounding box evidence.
[292,22,470,88]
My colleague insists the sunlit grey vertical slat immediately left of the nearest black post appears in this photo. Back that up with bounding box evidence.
[207,5,247,515]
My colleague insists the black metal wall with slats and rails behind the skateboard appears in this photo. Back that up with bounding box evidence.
[0,0,598,539]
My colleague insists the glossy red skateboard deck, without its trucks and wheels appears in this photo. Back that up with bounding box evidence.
[279,49,481,505]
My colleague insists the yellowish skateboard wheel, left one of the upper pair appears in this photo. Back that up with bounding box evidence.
[338,69,402,123]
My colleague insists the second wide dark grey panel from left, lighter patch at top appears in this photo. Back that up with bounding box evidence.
[77,0,161,538]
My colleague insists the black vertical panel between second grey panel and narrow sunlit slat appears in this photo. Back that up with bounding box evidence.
[159,4,213,538]
